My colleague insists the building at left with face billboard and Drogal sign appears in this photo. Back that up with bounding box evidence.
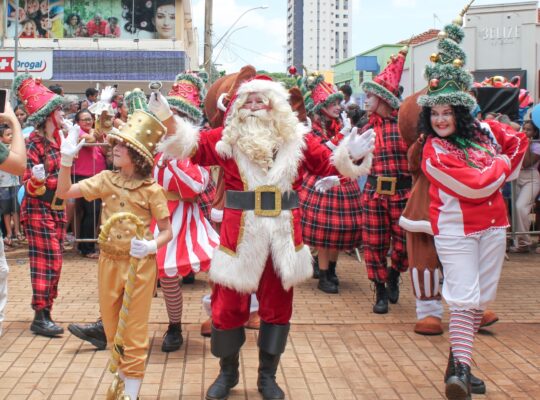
[0,0,199,94]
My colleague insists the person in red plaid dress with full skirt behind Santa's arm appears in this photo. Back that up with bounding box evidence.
[300,75,362,293]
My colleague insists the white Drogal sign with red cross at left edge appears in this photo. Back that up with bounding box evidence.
[0,51,53,79]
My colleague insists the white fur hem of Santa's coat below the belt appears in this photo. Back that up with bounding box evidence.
[209,211,313,293]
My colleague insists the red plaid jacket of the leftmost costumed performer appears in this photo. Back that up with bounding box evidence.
[21,131,66,222]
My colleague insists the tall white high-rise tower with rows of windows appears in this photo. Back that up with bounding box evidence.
[287,0,352,71]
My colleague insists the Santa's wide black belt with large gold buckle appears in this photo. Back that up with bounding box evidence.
[225,186,300,217]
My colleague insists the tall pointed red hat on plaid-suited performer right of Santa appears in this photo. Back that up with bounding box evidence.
[362,47,408,109]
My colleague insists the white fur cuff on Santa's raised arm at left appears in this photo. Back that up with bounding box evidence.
[157,115,200,160]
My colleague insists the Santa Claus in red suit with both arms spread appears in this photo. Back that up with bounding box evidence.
[149,76,374,399]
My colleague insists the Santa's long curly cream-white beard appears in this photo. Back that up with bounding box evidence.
[231,109,283,171]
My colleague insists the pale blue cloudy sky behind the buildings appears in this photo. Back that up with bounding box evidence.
[192,0,536,73]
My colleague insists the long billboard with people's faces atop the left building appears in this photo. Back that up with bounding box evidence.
[4,0,176,39]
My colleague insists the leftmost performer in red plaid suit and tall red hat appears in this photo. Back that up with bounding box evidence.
[13,74,66,337]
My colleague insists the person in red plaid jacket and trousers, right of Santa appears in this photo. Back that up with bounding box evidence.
[362,47,412,314]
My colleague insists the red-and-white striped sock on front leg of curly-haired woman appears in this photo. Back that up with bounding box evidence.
[449,310,475,366]
